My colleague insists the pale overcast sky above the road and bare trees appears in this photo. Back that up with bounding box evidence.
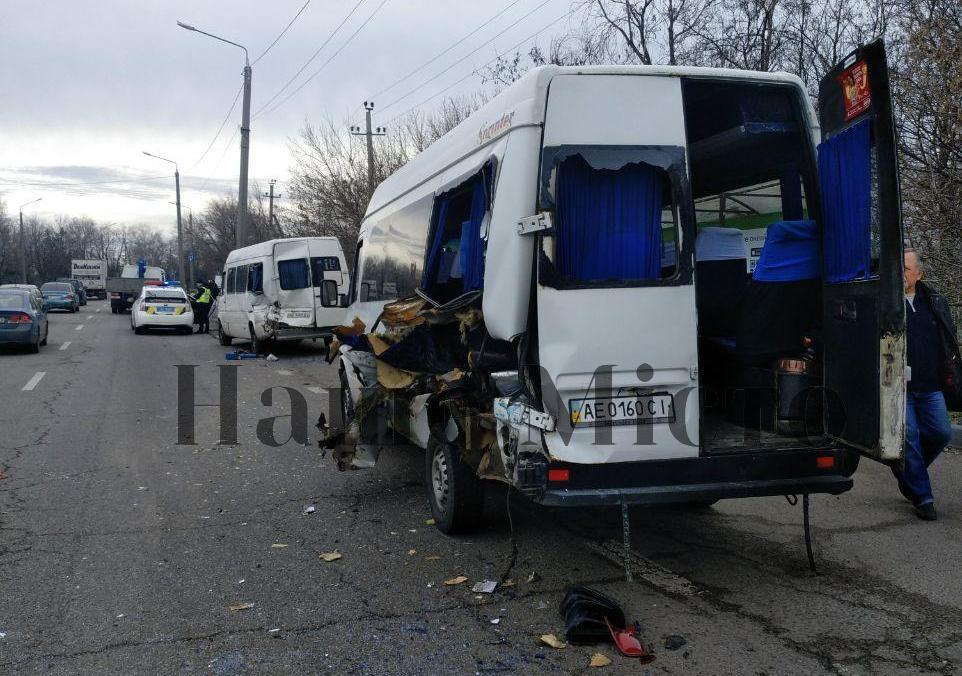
[0,0,571,228]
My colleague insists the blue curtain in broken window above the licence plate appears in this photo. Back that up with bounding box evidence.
[556,156,662,282]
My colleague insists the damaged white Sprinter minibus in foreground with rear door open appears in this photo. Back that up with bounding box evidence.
[329,41,905,532]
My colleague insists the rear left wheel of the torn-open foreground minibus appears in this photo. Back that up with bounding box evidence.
[424,434,484,535]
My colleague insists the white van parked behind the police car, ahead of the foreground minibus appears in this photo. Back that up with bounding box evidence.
[217,237,349,351]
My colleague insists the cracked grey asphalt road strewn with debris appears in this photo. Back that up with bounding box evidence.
[0,301,962,674]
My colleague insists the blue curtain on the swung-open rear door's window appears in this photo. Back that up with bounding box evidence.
[818,120,872,284]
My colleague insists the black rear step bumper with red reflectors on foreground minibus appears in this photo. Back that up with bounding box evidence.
[518,449,858,507]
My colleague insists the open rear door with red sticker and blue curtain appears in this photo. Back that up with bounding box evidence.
[818,40,905,462]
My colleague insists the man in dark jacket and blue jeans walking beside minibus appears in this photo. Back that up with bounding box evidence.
[897,249,959,521]
